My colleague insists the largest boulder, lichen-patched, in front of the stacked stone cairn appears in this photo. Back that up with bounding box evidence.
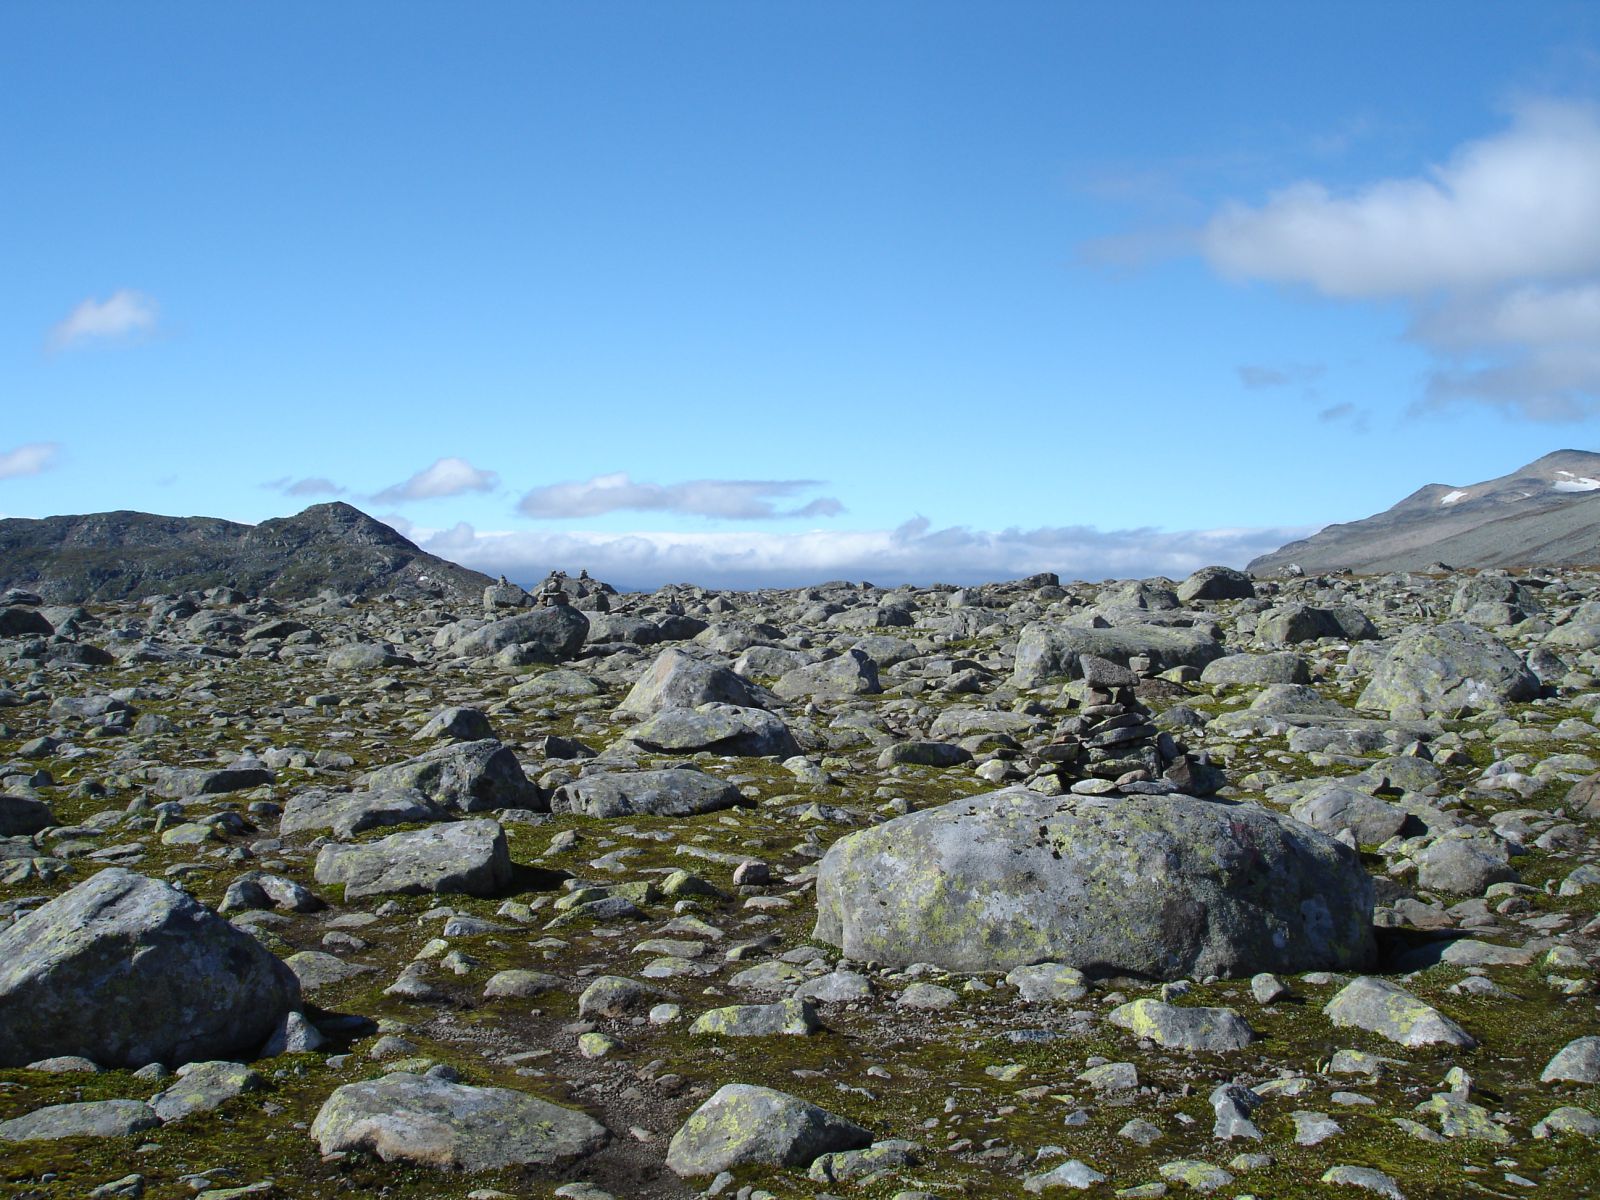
[814,789,1373,979]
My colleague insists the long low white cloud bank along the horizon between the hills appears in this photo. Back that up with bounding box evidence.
[419,518,1314,587]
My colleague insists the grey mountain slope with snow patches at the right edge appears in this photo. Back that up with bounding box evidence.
[1248,450,1600,576]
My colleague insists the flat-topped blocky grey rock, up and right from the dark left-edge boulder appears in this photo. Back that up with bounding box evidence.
[315,818,512,901]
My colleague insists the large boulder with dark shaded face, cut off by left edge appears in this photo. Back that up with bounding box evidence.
[0,867,301,1067]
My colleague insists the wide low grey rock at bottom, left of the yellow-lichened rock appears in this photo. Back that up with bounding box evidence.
[310,1072,610,1171]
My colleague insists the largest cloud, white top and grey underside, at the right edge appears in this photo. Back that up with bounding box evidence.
[1200,101,1600,421]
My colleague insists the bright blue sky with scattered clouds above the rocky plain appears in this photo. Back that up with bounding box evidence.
[0,0,1600,586]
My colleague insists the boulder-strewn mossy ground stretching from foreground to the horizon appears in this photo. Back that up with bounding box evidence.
[0,570,1600,1200]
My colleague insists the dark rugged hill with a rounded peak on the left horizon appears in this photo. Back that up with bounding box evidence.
[0,502,491,603]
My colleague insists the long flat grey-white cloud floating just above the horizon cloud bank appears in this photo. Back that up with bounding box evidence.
[517,472,845,520]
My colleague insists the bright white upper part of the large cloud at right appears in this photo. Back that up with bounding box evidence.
[1200,102,1600,298]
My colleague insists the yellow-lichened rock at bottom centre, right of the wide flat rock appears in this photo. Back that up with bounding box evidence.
[667,1083,872,1178]
